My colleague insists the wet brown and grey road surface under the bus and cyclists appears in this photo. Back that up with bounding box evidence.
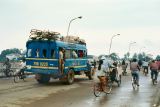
[0,68,160,107]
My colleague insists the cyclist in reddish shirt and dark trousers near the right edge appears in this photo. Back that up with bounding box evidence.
[150,60,158,83]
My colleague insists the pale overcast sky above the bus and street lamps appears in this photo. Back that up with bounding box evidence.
[0,0,160,57]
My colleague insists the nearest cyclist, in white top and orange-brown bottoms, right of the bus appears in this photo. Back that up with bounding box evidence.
[97,59,107,92]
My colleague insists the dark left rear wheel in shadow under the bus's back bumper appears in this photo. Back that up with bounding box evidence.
[35,74,50,84]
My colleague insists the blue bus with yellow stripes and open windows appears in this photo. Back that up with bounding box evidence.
[26,35,94,84]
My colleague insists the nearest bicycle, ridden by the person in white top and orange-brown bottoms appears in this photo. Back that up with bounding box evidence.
[93,72,112,97]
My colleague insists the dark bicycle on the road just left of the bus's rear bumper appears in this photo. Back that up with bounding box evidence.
[14,69,26,83]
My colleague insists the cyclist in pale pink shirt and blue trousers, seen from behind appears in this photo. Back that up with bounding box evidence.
[130,59,140,86]
